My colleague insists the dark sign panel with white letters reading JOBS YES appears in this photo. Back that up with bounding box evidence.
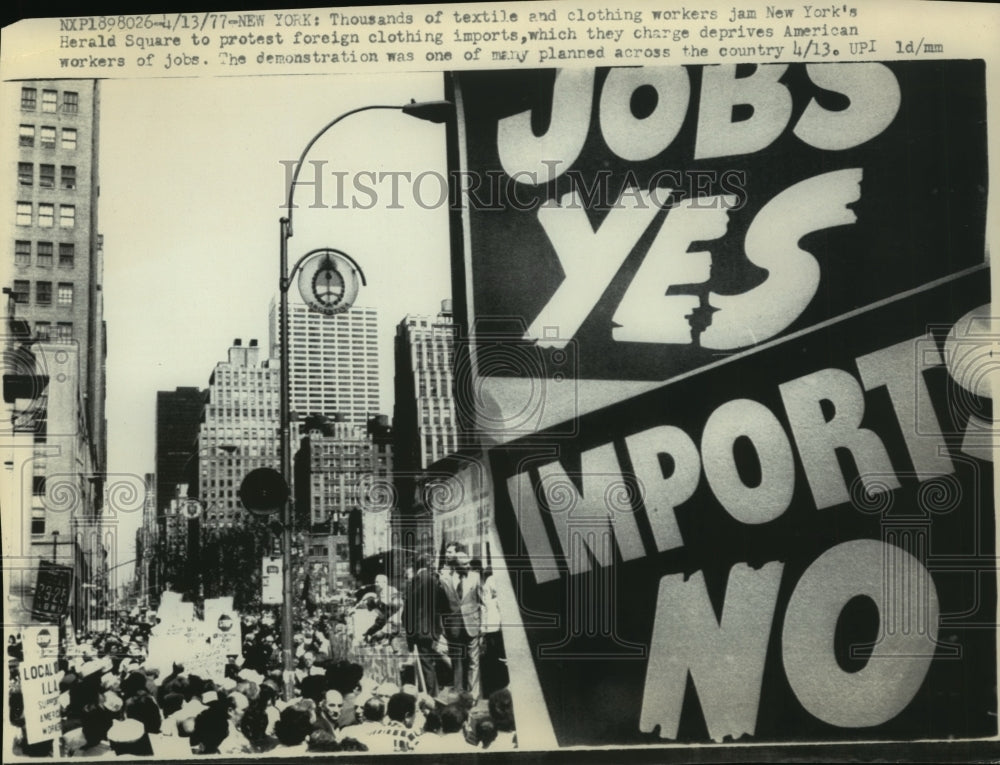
[455,61,985,380]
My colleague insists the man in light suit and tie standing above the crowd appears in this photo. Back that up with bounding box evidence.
[440,547,483,698]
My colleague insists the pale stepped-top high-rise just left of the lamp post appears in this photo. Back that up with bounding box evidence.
[191,339,281,528]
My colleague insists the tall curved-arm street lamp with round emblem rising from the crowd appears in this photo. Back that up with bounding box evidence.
[278,101,454,698]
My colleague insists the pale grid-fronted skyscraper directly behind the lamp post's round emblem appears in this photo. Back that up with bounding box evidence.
[270,300,381,428]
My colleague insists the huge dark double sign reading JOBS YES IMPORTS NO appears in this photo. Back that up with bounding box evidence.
[452,61,997,745]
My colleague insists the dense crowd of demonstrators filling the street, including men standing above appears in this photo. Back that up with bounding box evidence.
[8,543,517,759]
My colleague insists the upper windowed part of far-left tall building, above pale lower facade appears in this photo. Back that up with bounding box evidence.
[4,80,106,472]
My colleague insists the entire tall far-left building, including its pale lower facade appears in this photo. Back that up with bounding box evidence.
[0,80,107,626]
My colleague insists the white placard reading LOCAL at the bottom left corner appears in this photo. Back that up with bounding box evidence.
[19,625,63,744]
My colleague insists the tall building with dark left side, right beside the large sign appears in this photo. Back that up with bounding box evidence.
[393,300,458,510]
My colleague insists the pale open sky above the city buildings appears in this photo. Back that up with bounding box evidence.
[98,73,451,581]
